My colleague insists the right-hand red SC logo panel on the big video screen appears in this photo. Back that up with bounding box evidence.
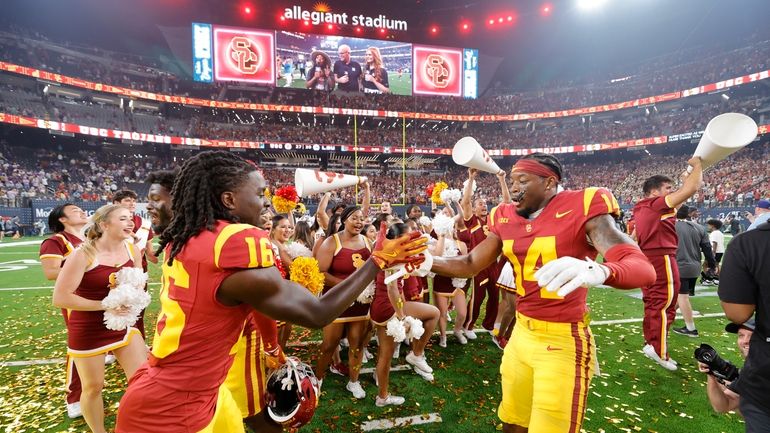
[412,45,464,97]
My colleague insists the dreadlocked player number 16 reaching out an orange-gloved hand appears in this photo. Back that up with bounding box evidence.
[116,151,425,433]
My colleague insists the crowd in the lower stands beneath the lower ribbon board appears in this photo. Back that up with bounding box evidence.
[0,142,770,207]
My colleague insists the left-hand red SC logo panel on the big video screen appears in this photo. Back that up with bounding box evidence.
[213,26,276,85]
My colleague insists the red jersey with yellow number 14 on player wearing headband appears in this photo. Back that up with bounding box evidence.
[489,188,620,323]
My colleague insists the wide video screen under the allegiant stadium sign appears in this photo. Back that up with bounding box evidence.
[192,23,478,98]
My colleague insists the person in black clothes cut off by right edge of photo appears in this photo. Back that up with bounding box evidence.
[718,223,770,433]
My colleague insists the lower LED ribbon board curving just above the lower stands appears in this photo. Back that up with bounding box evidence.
[0,113,770,157]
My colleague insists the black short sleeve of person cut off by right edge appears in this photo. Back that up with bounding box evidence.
[717,237,759,305]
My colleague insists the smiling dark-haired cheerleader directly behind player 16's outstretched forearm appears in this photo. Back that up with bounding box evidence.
[315,206,372,399]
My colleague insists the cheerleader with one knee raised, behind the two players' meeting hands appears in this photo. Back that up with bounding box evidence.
[371,223,439,394]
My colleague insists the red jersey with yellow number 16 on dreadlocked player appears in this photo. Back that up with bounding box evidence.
[149,221,274,392]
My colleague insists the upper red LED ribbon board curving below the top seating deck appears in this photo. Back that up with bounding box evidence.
[0,61,770,122]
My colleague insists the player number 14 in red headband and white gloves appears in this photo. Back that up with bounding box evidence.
[432,153,655,433]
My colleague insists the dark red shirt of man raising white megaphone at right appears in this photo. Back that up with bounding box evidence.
[634,196,679,255]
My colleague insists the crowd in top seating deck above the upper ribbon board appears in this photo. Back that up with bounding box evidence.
[0,28,770,114]
